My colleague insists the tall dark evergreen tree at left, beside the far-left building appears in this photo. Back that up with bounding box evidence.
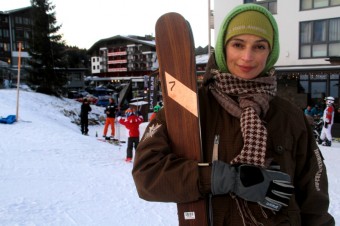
[29,0,66,95]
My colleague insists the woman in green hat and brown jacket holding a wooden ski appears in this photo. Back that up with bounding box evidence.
[132,4,335,226]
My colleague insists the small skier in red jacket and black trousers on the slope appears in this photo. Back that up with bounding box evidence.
[118,108,144,162]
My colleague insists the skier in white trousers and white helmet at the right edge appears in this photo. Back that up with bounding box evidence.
[320,96,335,146]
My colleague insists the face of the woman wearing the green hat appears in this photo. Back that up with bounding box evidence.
[226,34,270,79]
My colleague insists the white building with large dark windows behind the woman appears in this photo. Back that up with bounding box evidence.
[214,0,340,108]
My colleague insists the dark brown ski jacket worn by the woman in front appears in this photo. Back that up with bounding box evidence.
[132,57,335,226]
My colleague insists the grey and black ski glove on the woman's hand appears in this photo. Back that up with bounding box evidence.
[211,161,294,211]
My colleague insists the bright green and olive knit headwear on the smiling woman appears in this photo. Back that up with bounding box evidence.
[215,3,280,74]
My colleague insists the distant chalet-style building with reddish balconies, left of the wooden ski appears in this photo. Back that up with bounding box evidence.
[88,35,158,82]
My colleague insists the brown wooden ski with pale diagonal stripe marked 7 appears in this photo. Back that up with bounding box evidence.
[156,13,209,226]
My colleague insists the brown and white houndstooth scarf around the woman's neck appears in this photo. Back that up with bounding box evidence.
[209,69,276,167]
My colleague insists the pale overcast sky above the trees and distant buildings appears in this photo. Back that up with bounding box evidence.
[0,0,214,49]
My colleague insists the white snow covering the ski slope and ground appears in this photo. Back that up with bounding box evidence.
[0,89,340,226]
